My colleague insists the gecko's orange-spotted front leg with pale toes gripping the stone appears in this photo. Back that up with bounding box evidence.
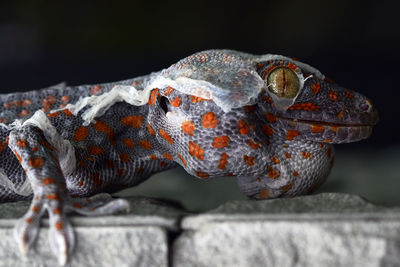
[9,125,74,264]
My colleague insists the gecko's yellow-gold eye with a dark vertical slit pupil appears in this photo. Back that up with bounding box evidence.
[267,67,300,98]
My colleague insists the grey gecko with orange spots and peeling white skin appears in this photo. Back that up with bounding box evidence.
[0,50,378,264]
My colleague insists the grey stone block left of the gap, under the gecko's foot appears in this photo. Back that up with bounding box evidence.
[0,198,185,267]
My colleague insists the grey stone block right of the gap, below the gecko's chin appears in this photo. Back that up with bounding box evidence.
[173,193,400,267]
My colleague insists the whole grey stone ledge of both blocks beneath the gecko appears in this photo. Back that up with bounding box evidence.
[0,193,400,267]
